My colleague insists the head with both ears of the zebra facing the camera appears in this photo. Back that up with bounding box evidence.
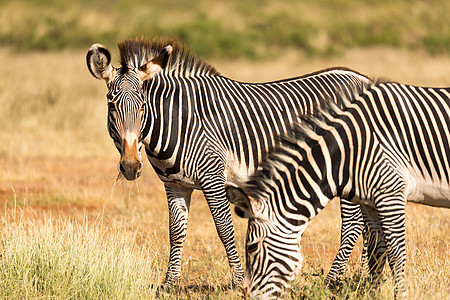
[86,44,172,180]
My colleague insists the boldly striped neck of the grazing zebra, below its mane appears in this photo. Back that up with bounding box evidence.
[246,112,364,225]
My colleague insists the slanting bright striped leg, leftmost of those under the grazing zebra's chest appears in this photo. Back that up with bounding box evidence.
[325,199,364,288]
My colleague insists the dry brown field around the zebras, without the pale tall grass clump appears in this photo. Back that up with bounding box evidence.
[0,48,450,299]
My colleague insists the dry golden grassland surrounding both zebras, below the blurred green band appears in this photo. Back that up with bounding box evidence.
[0,45,450,299]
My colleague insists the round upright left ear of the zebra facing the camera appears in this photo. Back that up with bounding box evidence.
[86,44,114,81]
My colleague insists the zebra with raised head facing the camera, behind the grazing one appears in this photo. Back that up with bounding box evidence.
[86,39,371,286]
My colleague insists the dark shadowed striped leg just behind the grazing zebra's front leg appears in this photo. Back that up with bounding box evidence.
[361,205,386,284]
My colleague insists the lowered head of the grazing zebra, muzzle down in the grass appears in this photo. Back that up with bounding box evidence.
[226,184,303,299]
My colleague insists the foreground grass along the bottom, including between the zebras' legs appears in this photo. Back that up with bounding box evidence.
[0,199,450,299]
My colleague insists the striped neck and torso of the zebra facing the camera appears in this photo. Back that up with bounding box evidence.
[143,70,370,188]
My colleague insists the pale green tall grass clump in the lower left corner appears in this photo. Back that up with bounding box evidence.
[0,212,163,299]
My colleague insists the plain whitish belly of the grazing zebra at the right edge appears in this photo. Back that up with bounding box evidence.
[406,176,450,208]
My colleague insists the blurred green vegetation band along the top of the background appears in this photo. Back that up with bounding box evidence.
[0,0,450,58]
